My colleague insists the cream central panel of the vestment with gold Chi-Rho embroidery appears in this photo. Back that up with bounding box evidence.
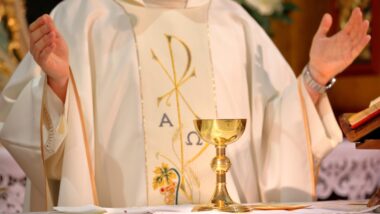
[123,2,216,205]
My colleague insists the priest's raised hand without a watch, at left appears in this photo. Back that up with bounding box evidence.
[29,14,70,102]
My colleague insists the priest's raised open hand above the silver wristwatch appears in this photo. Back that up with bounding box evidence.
[309,8,371,85]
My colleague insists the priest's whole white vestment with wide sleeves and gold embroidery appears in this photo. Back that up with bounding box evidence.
[0,0,342,211]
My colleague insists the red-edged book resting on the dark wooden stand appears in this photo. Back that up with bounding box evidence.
[348,97,380,129]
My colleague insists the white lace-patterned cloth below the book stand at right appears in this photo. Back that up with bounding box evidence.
[317,140,380,200]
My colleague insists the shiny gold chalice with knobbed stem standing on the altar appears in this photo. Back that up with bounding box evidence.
[192,119,250,212]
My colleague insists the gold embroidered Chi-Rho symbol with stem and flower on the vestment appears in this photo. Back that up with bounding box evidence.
[150,34,208,204]
